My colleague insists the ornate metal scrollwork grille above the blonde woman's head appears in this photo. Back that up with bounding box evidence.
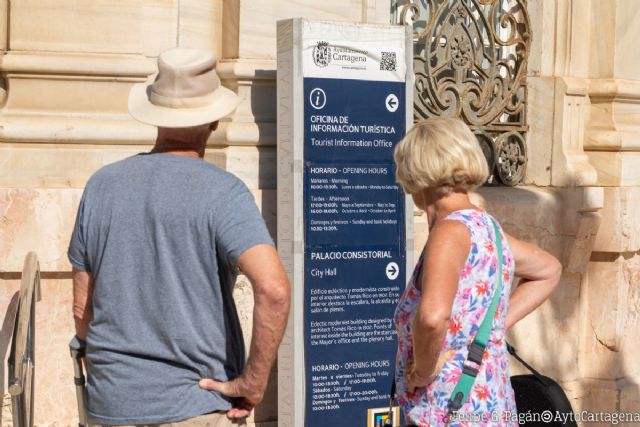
[392,0,531,185]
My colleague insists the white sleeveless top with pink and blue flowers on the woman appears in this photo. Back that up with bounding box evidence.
[395,209,517,427]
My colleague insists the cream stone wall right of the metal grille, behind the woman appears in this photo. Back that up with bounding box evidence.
[480,0,640,418]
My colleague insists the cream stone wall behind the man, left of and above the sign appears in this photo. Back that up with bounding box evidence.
[0,0,389,426]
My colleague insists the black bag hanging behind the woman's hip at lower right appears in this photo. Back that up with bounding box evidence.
[507,344,577,427]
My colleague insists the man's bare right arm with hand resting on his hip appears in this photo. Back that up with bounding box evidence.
[200,244,291,419]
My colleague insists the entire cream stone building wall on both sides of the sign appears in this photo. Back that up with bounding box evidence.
[0,0,640,426]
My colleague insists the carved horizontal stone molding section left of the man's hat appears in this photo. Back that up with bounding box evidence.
[0,51,155,144]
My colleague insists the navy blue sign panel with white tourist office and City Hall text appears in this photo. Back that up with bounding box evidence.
[304,78,406,427]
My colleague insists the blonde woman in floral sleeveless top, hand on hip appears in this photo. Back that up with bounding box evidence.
[394,118,561,427]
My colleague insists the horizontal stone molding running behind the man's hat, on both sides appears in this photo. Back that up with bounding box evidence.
[0,52,276,146]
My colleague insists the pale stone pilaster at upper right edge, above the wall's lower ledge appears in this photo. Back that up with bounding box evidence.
[585,0,640,186]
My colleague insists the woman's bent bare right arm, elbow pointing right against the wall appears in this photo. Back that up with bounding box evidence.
[505,235,562,329]
